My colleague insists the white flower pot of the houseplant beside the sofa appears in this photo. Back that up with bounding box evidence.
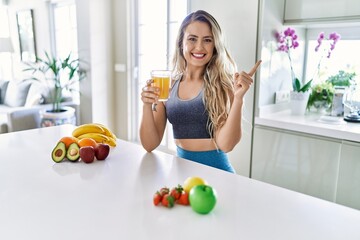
[40,107,76,127]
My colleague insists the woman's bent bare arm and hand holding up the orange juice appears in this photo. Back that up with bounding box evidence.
[140,80,166,152]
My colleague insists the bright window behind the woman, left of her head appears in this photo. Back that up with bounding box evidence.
[134,0,187,152]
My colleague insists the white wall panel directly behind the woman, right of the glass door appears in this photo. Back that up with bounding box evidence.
[190,0,258,176]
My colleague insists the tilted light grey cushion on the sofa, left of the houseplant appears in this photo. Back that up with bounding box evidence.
[4,81,31,107]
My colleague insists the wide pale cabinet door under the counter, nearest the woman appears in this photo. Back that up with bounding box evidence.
[251,126,341,201]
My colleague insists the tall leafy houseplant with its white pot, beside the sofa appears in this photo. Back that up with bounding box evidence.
[24,51,86,126]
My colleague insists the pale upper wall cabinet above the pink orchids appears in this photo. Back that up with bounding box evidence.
[284,0,360,22]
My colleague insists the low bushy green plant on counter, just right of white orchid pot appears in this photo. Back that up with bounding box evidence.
[307,82,335,112]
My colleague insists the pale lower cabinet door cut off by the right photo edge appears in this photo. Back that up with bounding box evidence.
[336,142,360,209]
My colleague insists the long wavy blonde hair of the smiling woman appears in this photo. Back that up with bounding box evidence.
[173,10,236,138]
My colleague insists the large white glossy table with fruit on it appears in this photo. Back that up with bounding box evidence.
[0,125,360,240]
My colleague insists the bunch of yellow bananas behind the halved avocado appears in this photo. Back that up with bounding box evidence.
[72,123,116,147]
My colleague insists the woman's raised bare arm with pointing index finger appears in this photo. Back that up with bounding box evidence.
[216,61,261,152]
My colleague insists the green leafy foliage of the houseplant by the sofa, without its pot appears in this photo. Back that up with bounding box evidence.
[24,51,86,112]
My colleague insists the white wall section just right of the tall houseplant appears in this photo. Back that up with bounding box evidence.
[76,0,115,129]
